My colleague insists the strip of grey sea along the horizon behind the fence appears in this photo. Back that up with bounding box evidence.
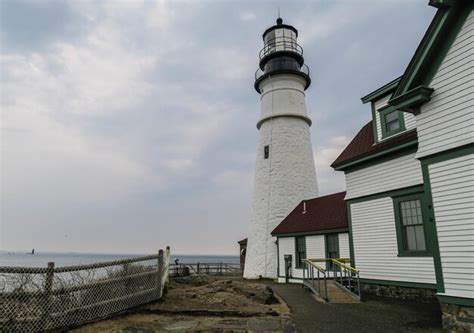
[0,251,239,267]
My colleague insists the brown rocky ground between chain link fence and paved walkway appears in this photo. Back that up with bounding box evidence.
[73,275,295,333]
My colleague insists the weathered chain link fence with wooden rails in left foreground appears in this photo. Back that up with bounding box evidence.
[0,248,170,332]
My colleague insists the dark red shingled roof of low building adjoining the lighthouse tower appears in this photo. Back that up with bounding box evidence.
[272,192,348,235]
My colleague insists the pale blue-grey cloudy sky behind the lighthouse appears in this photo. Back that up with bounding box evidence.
[0,0,435,255]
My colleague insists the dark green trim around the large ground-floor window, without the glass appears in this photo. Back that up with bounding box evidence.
[392,192,432,257]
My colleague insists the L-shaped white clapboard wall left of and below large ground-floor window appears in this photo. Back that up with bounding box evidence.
[350,197,436,284]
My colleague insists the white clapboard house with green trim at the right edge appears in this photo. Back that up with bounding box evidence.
[333,0,474,331]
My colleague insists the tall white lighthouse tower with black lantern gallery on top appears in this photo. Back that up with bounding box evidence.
[244,18,318,279]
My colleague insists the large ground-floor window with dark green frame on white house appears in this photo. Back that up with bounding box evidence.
[394,194,429,256]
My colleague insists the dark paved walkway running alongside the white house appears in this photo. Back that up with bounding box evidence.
[270,283,443,333]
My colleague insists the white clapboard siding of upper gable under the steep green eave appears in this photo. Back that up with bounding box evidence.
[416,11,474,157]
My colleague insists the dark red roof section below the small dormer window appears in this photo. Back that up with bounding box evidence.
[331,121,417,168]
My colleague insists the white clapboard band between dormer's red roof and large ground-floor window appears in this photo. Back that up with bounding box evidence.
[345,153,423,200]
